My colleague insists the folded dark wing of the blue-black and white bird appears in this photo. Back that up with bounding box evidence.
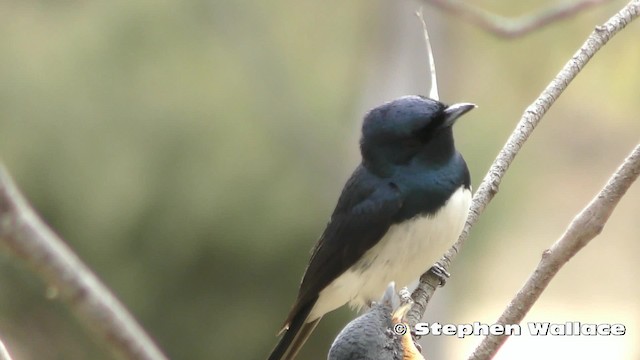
[285,167,402,326]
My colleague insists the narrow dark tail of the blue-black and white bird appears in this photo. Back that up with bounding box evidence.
[268,301,321,360]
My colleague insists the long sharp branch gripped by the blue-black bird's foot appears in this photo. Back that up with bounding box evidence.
[407,0,640,326]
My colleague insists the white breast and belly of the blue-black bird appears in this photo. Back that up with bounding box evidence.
[307,187,471,322]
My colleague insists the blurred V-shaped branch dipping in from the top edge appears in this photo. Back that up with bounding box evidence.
[424,0,610,39]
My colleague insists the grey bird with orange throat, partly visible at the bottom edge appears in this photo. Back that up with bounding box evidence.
[327,283,424,360]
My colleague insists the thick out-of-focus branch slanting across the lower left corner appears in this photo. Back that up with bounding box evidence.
[0,165,166,360]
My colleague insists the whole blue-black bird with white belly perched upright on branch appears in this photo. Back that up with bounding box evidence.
[269,96,475,360]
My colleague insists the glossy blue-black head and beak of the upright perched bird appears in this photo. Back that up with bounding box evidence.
[360,95,476,173]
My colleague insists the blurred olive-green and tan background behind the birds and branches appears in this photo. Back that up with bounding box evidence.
[0,0,640,360]
